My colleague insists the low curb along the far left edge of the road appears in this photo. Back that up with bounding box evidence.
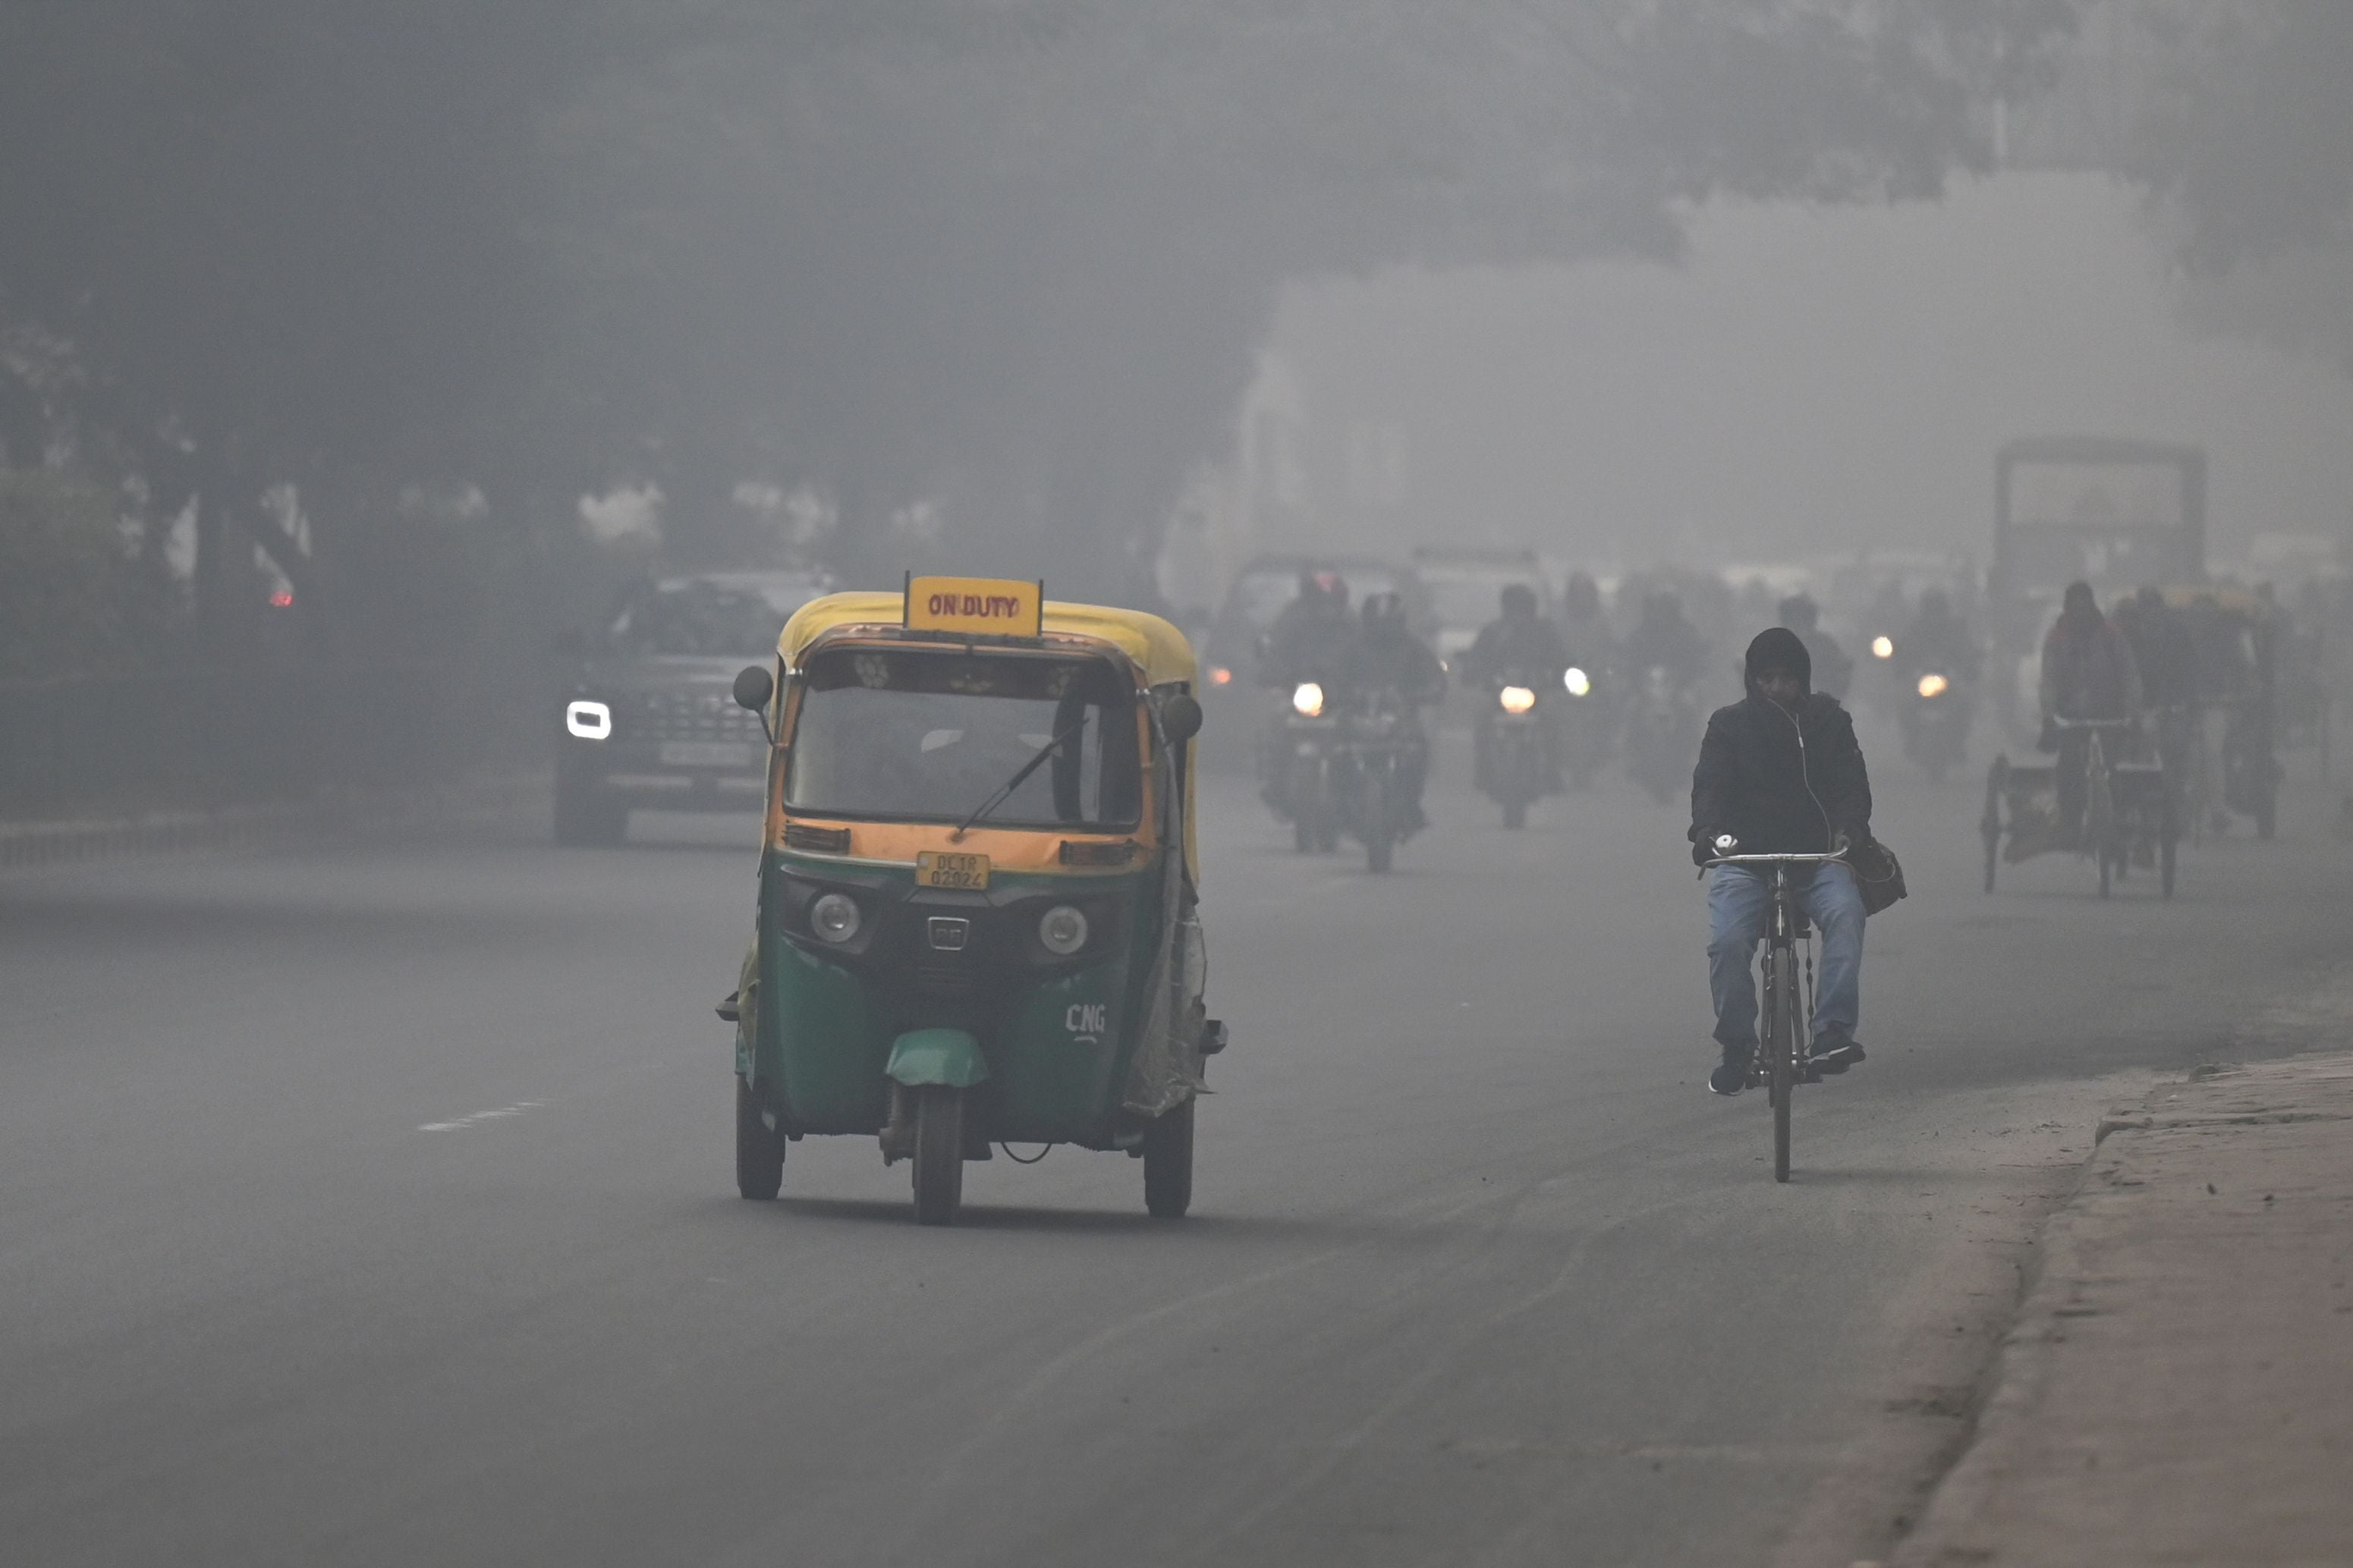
[0,776,553,872]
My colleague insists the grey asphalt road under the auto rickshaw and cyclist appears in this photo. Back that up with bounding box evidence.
[0,728,2344,1568]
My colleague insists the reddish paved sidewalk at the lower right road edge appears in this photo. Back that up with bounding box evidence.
[1894,1053,2353,1568]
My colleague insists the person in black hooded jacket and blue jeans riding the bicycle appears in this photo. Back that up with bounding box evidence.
[1690,625,1870,1095]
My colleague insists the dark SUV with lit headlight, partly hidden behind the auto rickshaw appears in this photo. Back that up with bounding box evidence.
[555,571,833,844]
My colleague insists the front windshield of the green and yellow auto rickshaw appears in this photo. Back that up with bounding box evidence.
[784,646,1143,832]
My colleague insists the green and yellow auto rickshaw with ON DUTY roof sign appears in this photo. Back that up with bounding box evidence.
[722,578,1226,1225]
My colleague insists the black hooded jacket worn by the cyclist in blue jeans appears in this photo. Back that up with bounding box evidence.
[1690,625,1870,860]
